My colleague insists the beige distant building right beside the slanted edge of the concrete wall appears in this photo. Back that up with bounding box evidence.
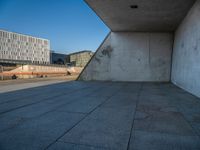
[69,50,94,67]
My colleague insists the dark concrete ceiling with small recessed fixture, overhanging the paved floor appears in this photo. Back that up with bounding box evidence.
[85,0,196,32]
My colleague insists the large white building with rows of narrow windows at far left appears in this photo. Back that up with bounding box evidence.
[0,30,50,64]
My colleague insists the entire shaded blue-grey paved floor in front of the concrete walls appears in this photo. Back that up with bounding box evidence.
[0,81,200,150]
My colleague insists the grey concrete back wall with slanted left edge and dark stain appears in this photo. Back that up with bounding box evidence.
[79,32,173,81]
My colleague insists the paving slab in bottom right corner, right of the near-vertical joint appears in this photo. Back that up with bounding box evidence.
[129,131,200,150]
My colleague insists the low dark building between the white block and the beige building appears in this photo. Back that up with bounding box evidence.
[50,51,69,65]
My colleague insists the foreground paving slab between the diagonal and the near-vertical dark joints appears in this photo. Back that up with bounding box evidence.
[59,108,134,150]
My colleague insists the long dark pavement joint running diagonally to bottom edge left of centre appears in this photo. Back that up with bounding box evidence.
[44,83,125,150]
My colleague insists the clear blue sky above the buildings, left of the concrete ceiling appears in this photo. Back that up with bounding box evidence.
[0,0,109,53]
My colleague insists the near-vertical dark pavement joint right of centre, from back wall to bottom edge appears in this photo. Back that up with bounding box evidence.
[127,83,143,150]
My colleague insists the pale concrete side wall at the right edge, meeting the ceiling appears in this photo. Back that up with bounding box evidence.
[172,0,200,97]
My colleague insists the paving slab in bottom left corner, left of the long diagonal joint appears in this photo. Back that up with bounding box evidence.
[0,112,84,150]
